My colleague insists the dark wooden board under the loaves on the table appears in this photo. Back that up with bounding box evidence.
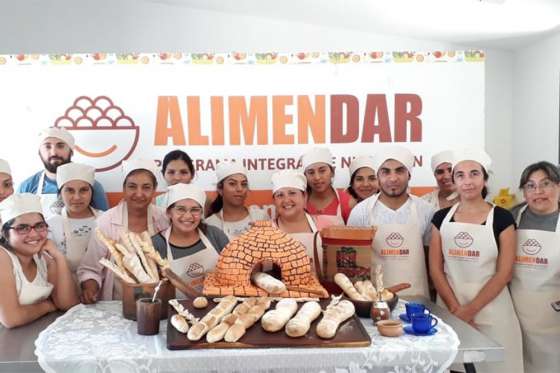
[167,299,371,350]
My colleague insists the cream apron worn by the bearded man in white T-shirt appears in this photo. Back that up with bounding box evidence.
[368,194,430,299]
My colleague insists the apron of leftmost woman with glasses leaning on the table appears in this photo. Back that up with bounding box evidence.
[3,248,53,306]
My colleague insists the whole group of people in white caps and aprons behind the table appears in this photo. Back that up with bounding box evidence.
[0,127,560,372]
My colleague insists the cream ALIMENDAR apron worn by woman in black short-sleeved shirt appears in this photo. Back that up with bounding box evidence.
[440,203,523,373]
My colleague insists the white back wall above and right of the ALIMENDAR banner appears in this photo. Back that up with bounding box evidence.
[0,0,516,192]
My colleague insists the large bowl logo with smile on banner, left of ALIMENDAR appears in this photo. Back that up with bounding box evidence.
[54,96,140,172]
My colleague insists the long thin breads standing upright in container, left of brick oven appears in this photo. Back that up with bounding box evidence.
[96,229,169,284]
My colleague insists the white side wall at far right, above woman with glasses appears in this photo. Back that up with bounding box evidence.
[512,32,560,187]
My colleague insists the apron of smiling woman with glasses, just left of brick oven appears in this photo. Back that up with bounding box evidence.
[163,227,220,296]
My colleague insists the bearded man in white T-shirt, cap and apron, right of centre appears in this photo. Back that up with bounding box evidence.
[348,146,434,298]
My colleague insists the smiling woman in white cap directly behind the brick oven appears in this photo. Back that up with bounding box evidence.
[272,170,336,269]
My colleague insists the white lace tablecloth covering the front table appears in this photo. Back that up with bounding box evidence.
[35,301,459,373]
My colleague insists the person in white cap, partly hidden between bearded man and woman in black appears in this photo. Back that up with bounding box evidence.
[422,150,459,211]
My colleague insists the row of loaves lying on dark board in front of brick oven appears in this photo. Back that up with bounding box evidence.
[170,296,355,343]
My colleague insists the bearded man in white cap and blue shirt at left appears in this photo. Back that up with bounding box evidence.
[18,127,108,219]
